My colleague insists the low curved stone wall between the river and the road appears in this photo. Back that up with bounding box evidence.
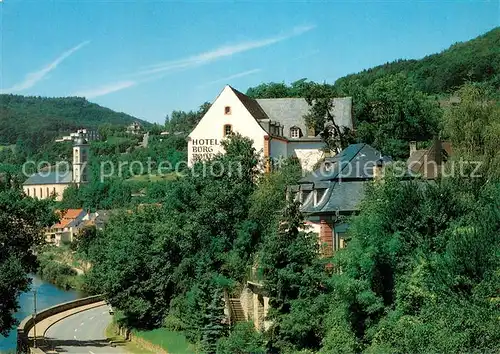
[16,295,103,354]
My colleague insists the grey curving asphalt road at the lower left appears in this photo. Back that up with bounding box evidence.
[45,306,125,354]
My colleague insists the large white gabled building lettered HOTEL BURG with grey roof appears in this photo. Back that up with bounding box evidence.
[188,85,353,170]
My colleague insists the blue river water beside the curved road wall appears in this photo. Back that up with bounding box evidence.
[0,276,84,353]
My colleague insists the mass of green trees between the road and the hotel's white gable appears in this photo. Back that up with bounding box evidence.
[79,135,300,352]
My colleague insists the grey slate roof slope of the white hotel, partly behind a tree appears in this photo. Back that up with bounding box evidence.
[256,97,353,138]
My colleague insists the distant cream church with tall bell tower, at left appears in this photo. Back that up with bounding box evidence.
[23,134,89,201]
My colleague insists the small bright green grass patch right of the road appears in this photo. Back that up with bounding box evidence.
[134,328,194,354]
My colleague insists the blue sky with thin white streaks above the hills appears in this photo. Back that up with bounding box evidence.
[0,0,500,123]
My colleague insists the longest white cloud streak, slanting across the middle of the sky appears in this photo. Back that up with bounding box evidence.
[139,26,315,75]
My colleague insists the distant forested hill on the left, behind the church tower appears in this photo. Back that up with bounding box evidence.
[0,94,149,147]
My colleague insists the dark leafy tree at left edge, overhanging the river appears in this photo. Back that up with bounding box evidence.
[0,186,57,336]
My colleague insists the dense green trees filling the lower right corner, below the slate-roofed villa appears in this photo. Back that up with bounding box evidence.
[263,85,500,353]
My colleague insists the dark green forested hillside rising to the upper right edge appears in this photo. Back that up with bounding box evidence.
[335,27,500,94]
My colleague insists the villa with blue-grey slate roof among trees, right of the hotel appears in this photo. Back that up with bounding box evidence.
[289,144,394,255]
